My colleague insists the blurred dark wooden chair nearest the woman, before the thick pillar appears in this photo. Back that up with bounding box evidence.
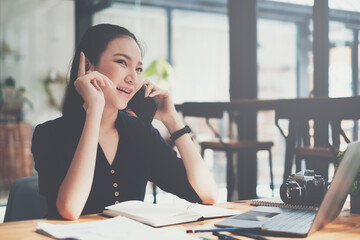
[181,103,274,201]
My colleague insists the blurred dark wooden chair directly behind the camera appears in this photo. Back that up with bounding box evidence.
[275,104,350,185]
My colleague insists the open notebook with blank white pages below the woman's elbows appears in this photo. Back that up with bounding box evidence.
[103,200,241,227]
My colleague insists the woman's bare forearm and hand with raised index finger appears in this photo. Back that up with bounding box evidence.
[56,53,113,220]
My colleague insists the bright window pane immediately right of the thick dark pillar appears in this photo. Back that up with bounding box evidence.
[257,19,297,99]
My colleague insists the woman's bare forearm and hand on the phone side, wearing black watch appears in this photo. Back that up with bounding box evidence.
[145,80,218,204]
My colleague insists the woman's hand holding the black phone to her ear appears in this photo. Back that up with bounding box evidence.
[144,79,176,122]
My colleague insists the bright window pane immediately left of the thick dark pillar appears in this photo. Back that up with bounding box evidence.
[173,11,230,102]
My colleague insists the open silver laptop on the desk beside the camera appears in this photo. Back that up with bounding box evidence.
[215,142,360,237]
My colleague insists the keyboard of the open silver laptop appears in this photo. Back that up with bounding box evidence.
[263,210,316,233]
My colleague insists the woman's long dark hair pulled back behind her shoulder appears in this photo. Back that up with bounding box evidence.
[62,24,143,118]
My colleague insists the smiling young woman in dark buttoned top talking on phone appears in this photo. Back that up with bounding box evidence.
[32,24,217,220]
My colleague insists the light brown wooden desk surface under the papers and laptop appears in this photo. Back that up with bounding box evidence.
[0,201,360,240]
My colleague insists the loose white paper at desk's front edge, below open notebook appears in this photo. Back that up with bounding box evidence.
[36,216,198,240]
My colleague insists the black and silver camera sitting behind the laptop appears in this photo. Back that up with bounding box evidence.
[280,170,326,205]
